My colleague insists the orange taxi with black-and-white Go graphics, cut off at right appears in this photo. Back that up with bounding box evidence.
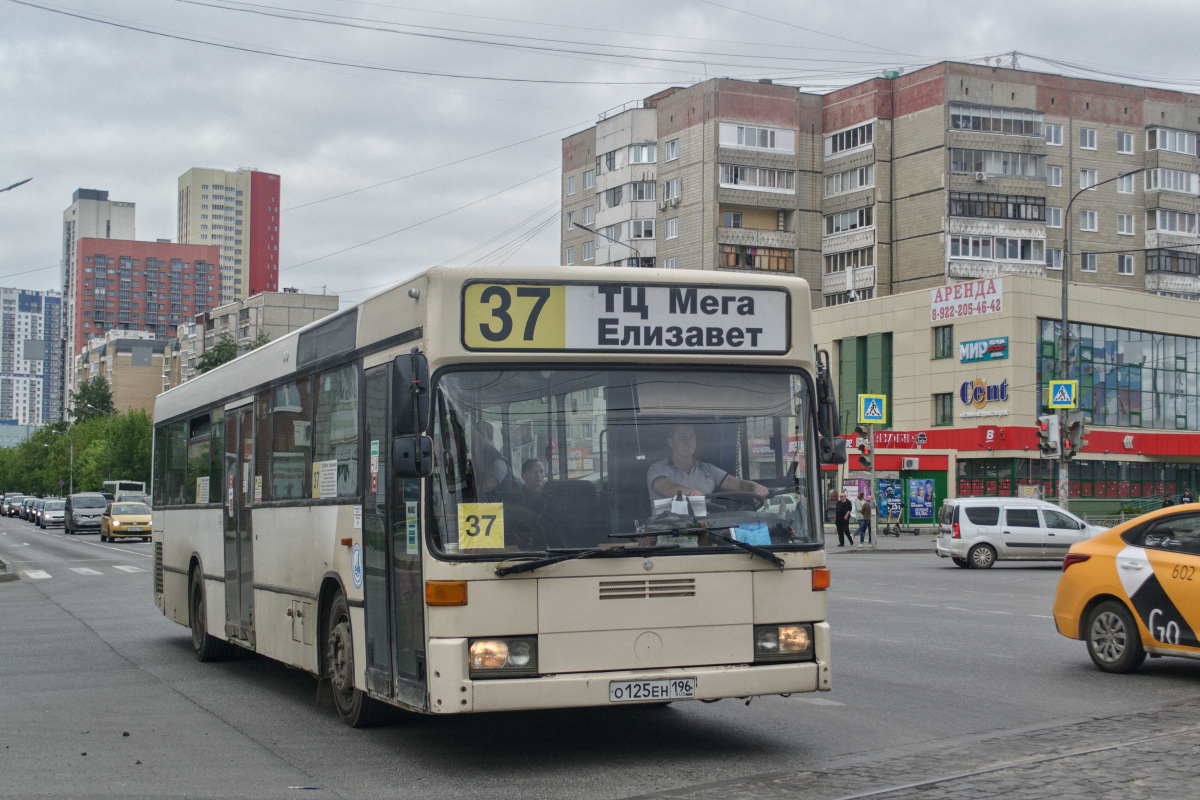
[1054,504,1200,673]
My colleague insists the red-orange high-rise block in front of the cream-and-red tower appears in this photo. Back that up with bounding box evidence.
[64,239,221,412]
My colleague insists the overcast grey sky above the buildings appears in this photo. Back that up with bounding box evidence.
[0,0,1200,300]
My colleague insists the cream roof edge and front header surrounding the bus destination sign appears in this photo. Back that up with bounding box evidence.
[154,266,814,422]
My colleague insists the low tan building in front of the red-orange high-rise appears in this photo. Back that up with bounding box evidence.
[72,330,168,413]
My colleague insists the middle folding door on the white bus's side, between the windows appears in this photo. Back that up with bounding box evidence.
[222,403,254,645]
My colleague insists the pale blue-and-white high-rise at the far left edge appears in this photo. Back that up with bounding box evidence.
[0,289,62,426]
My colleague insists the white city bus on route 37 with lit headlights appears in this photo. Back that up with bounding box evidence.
[154,267,845,726]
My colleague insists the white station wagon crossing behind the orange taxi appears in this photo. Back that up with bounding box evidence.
[937,498,1106,570]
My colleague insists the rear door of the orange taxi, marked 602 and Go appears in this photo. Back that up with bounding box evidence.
[1117,513,1200,651]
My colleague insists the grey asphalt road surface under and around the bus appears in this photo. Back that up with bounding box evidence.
[0,519,1200,799]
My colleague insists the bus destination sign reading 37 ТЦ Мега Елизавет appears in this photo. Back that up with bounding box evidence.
[462,283,791,355]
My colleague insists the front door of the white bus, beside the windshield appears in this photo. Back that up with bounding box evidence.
[362,365,426,708]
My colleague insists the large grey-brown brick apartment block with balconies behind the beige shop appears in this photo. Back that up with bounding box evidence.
[562,62,1200,306]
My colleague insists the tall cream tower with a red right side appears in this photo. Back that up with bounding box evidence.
[179,167,280,303]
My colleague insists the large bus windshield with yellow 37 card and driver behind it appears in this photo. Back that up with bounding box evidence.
[430,366,823,559]
